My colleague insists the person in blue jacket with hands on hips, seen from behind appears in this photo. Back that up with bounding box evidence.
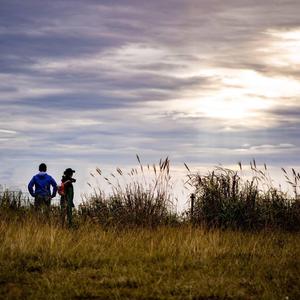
[28,163,57,208]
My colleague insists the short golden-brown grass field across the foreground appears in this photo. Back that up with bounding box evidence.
[0,219,300,299]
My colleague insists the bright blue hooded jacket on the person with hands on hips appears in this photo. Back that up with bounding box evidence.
[28,172,57,198]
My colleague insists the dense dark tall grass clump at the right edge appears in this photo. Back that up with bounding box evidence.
[186,160,300,230]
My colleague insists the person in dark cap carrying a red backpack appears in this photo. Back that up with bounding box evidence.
[60,168,76,227]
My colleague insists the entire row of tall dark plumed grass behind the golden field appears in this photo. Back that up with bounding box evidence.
[0,156,300,231]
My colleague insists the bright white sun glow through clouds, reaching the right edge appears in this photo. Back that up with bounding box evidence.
[171,28,300,126]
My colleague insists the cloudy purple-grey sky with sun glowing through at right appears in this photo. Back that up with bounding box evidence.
[0,0,300,206]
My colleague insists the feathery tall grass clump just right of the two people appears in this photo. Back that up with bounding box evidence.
[79,156,176,226]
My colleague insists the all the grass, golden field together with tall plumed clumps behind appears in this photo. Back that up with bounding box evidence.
[0,158,300,300]
